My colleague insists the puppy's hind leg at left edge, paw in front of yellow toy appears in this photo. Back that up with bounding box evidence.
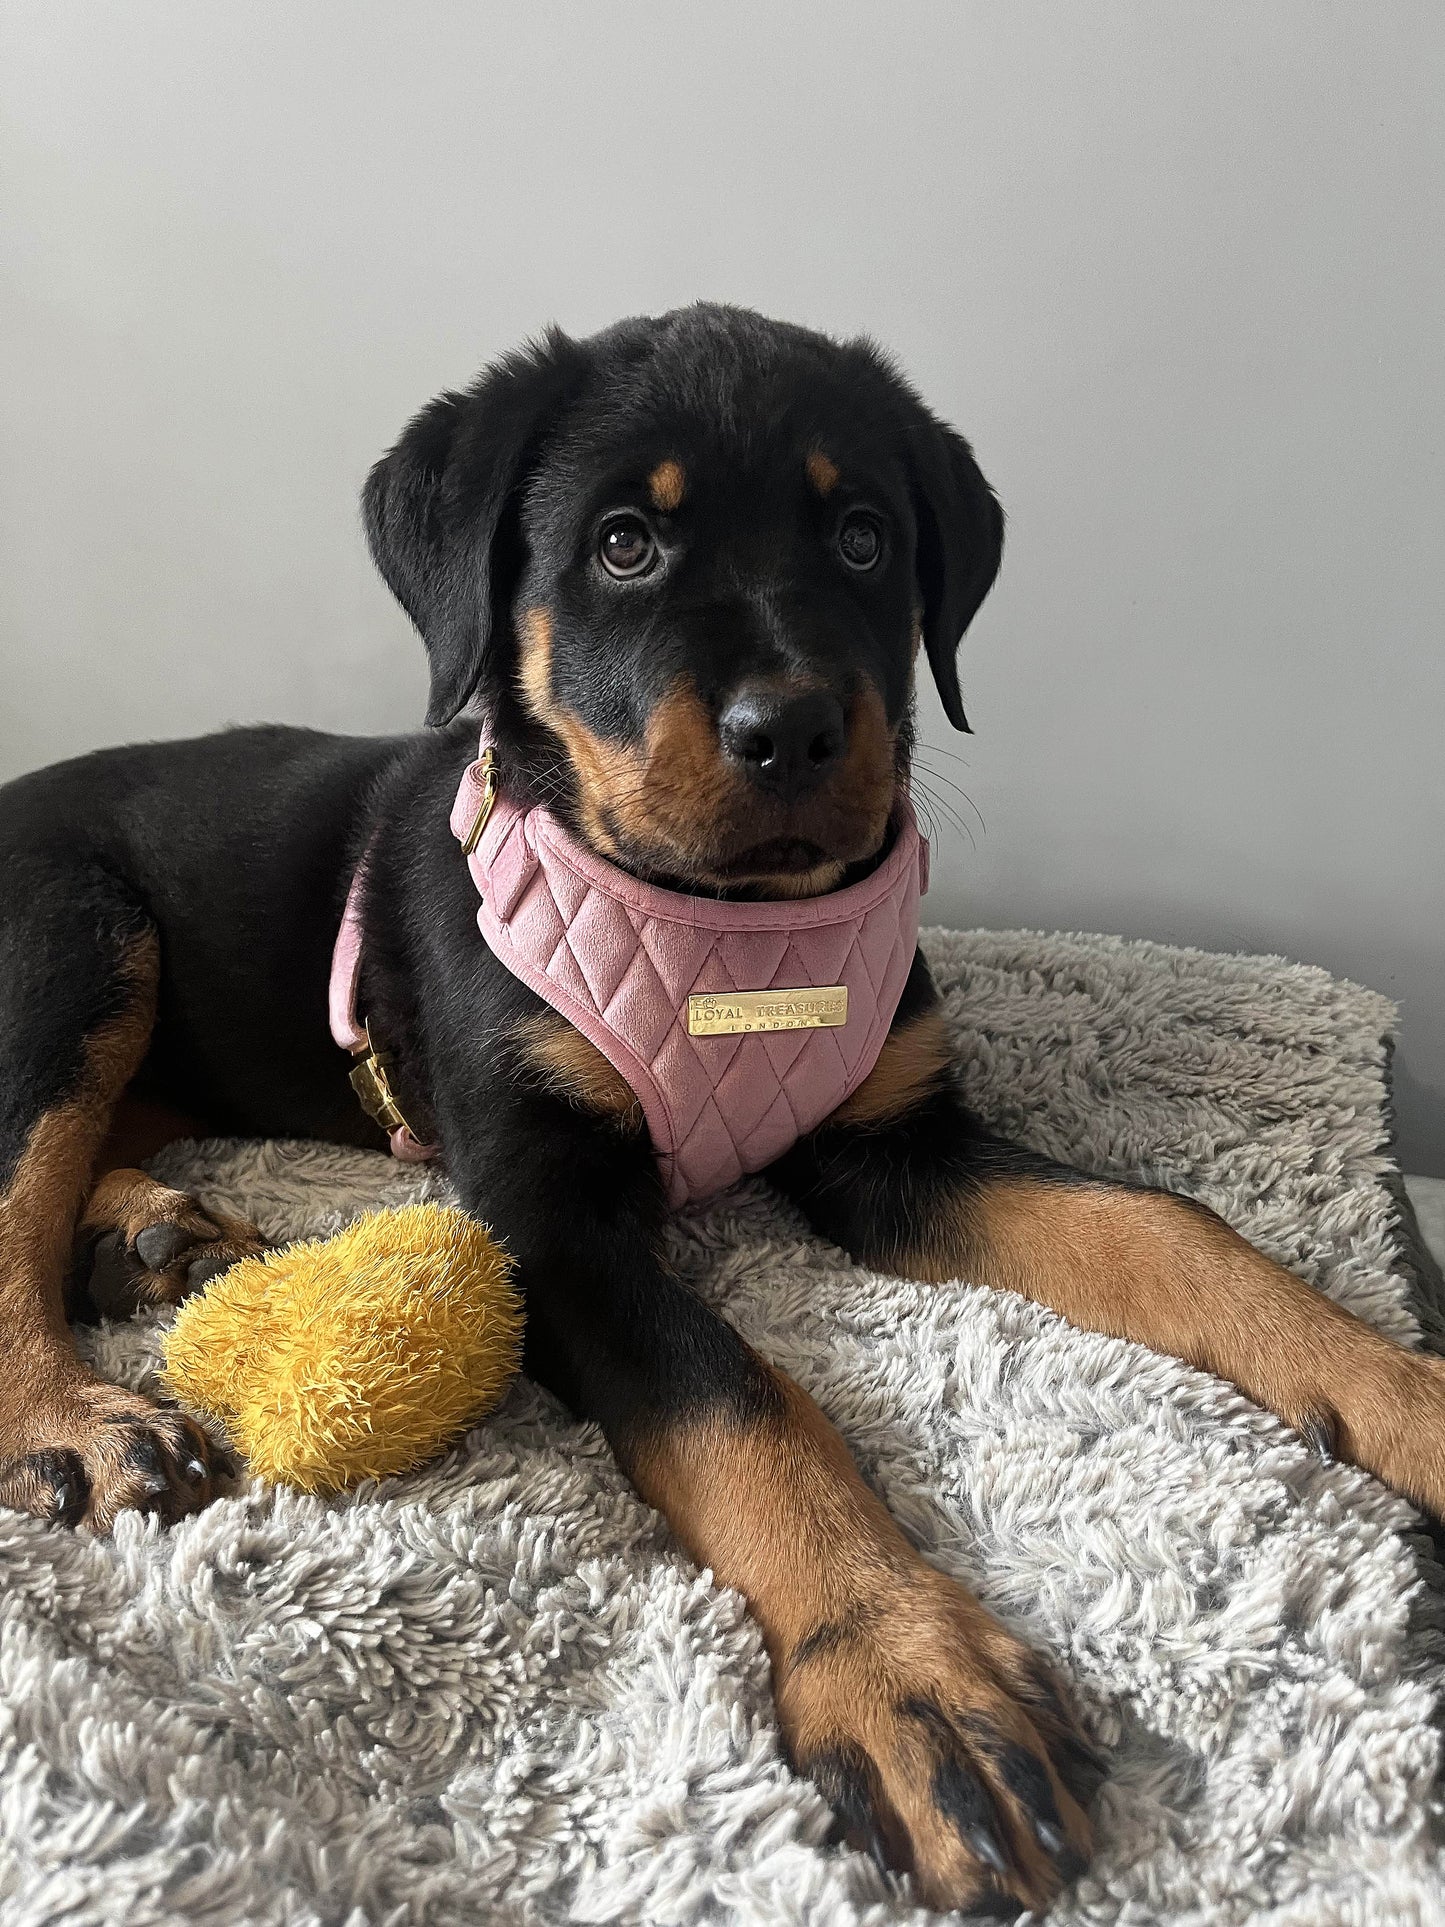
[0,879,227,1532]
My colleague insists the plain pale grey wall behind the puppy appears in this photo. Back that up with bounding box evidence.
[0,0,1445,1172]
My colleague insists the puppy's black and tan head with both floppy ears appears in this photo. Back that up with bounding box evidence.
[364,306,1004,896]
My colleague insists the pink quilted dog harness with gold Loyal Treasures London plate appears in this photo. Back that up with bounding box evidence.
[329,736,929,1204]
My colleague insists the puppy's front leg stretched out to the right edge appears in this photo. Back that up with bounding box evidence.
[773,955,1445,1517]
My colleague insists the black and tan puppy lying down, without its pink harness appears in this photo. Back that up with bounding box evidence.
[0,306,1445,1908]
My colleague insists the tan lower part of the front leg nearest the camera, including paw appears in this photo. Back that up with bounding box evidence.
[618,1359,1096,1914]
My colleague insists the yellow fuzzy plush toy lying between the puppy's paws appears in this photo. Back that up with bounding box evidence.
[164,1204,522,1491]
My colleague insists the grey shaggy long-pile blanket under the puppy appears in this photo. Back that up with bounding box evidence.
[0,933,1445,1927]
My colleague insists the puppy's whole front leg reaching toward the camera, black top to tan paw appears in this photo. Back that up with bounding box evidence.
[441,1071,1090,1914]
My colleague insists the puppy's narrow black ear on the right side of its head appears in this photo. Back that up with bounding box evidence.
[909,409,1004,732]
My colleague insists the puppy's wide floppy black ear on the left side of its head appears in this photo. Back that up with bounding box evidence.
[362,330,590,725]
